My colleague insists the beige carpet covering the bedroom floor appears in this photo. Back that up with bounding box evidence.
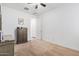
[15,40,79,56]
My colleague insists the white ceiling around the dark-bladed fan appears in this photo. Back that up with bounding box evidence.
[3,3,62,15]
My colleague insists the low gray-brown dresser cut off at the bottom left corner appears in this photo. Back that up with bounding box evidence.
[0,40,14,56]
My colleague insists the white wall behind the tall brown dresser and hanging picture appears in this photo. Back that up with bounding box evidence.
[2,6,35,40]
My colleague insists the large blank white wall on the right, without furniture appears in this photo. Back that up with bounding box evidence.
[40,4,79,50]
